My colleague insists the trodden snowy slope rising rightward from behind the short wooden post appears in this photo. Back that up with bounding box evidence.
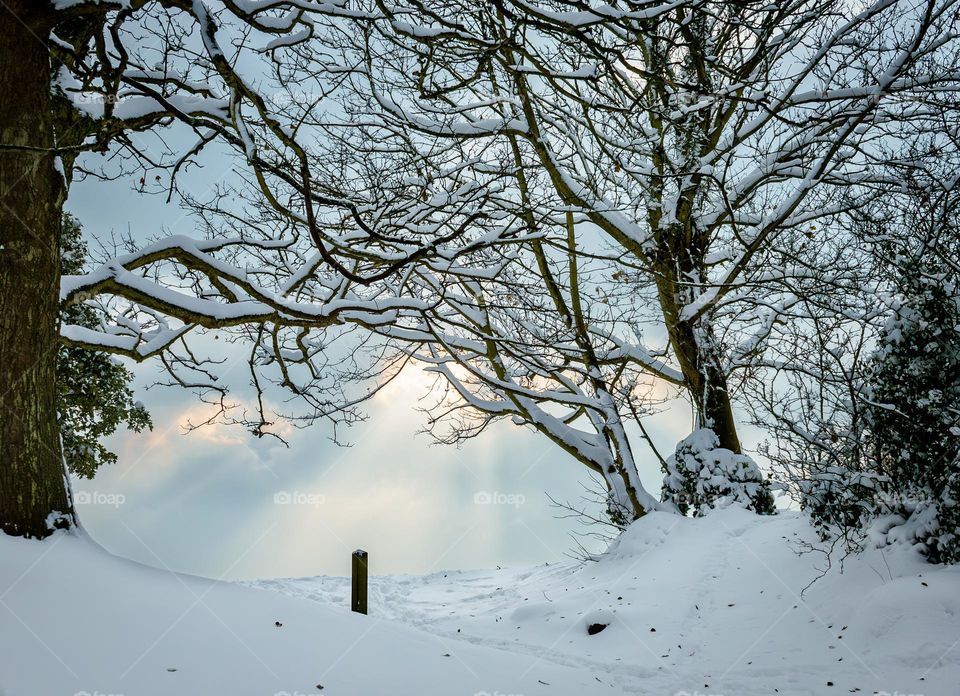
[258,509,960,696]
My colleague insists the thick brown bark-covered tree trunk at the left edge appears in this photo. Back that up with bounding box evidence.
[0,0,73,538]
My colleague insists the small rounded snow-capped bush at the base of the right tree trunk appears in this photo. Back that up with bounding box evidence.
[661,428,774,517]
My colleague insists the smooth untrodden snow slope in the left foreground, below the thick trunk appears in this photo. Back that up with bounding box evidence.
[0,534,597,696]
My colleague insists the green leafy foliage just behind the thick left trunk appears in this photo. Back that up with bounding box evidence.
[57,215,153,478]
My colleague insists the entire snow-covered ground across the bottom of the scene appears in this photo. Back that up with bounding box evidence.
[0,509,960,696]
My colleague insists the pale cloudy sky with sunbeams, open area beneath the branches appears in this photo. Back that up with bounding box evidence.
[67,135,690,579]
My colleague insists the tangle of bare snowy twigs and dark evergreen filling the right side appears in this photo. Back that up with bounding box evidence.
[753,156,960,562]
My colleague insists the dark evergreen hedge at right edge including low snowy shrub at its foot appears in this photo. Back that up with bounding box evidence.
[799,247,960,563]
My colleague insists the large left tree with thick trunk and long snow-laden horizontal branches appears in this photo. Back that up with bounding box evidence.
[0,0,510,537]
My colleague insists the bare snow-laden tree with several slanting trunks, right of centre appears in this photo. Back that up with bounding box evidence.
[300,0,960,521]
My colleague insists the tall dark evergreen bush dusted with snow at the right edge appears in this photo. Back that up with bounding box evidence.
[866,258,960,563]
